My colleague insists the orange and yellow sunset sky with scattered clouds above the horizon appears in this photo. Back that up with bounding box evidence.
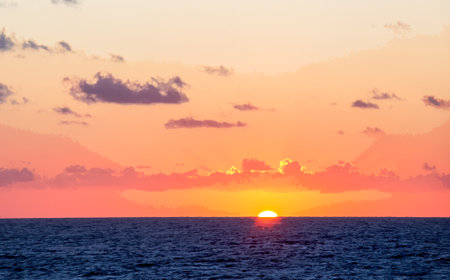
[0,0,450,218]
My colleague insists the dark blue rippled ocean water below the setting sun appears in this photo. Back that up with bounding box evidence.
[0,218,450,279]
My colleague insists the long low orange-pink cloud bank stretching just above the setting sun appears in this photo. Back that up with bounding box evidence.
[12,159,450,193]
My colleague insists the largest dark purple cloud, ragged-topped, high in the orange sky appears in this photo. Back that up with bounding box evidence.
[64,73,189,104]
